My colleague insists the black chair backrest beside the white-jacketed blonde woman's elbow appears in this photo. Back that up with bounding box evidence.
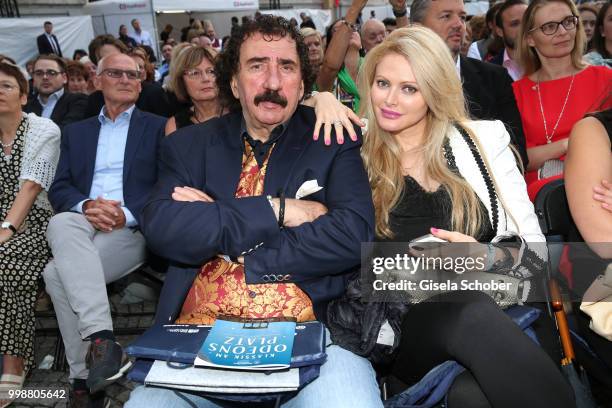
[534,179,574,241]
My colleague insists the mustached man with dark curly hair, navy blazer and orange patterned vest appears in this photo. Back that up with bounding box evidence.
[126,15,382,408]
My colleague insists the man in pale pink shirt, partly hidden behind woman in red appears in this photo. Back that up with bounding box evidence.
[491,0,527,81]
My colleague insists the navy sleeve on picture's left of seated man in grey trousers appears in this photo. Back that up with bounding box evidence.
[49,126,89,213]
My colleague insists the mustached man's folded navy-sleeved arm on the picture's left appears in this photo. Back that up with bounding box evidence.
[141,138,279,265]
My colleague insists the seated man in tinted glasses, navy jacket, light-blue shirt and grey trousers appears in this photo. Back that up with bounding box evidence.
[43,54,166,407]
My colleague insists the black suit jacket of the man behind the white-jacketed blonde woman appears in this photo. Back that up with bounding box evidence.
[460,57,528,168]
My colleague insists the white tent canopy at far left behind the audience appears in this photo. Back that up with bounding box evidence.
[0,16,94,66]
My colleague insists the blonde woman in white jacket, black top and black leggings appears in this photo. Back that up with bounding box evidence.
[328,26,574,408]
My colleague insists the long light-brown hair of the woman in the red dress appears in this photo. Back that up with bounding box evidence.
[516,0,586,76]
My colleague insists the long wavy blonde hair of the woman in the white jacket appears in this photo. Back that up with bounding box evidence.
[359,26,486,238]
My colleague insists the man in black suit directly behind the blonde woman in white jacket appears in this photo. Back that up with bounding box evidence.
[410,0,528,168]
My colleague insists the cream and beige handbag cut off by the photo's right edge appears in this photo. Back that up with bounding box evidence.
[580,263,612,341]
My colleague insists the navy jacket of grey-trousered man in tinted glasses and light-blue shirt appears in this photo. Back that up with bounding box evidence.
[49,109,166,218]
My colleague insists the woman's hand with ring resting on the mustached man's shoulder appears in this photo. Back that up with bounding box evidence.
[304,92,365,146]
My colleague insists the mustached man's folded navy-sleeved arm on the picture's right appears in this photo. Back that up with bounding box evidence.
[244,143,374,284]
